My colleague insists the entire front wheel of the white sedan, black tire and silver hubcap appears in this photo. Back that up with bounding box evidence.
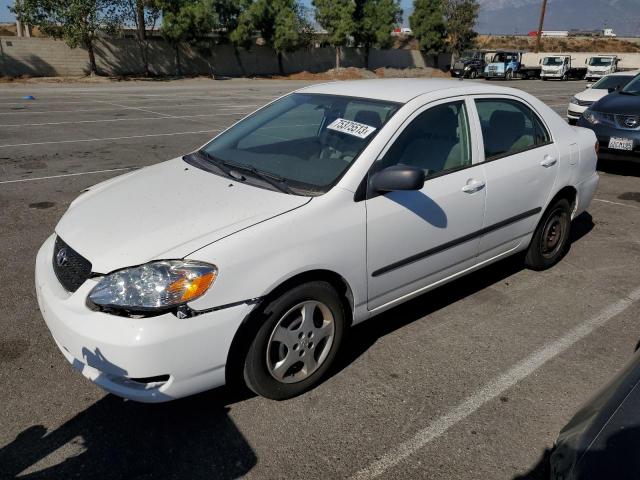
[244,281,346,400]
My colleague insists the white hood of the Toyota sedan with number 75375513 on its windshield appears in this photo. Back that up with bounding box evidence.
[56,158,310,273]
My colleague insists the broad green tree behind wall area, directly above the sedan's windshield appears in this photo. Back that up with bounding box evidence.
[231,0,310,73]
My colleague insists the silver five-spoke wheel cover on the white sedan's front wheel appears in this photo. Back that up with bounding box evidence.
[266,300,336,383]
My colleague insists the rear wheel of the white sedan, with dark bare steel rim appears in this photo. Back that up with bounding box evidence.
[525,198,571,270]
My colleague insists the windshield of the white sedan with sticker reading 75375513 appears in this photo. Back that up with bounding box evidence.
[202,93,400,194]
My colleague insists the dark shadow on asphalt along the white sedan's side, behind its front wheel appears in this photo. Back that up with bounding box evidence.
[328,212,594,382]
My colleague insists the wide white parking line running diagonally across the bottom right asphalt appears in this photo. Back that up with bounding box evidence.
[351,287,640,480]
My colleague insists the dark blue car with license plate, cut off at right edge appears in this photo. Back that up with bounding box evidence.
[578,75,640,161]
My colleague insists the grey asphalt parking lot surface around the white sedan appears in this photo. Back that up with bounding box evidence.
[0,79,640,479]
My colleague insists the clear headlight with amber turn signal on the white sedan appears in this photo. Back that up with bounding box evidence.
[89,260,218,311]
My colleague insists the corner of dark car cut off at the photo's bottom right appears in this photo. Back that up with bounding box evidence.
[551,352,640,480]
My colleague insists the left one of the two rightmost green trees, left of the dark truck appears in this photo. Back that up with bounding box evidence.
[409,0,447,55]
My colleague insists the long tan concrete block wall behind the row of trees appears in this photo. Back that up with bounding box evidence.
[0,37,451,76]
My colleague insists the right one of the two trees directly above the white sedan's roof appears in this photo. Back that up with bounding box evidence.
[353,0,402,68]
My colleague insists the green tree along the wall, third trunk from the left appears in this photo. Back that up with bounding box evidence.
[154,0,219,75]
